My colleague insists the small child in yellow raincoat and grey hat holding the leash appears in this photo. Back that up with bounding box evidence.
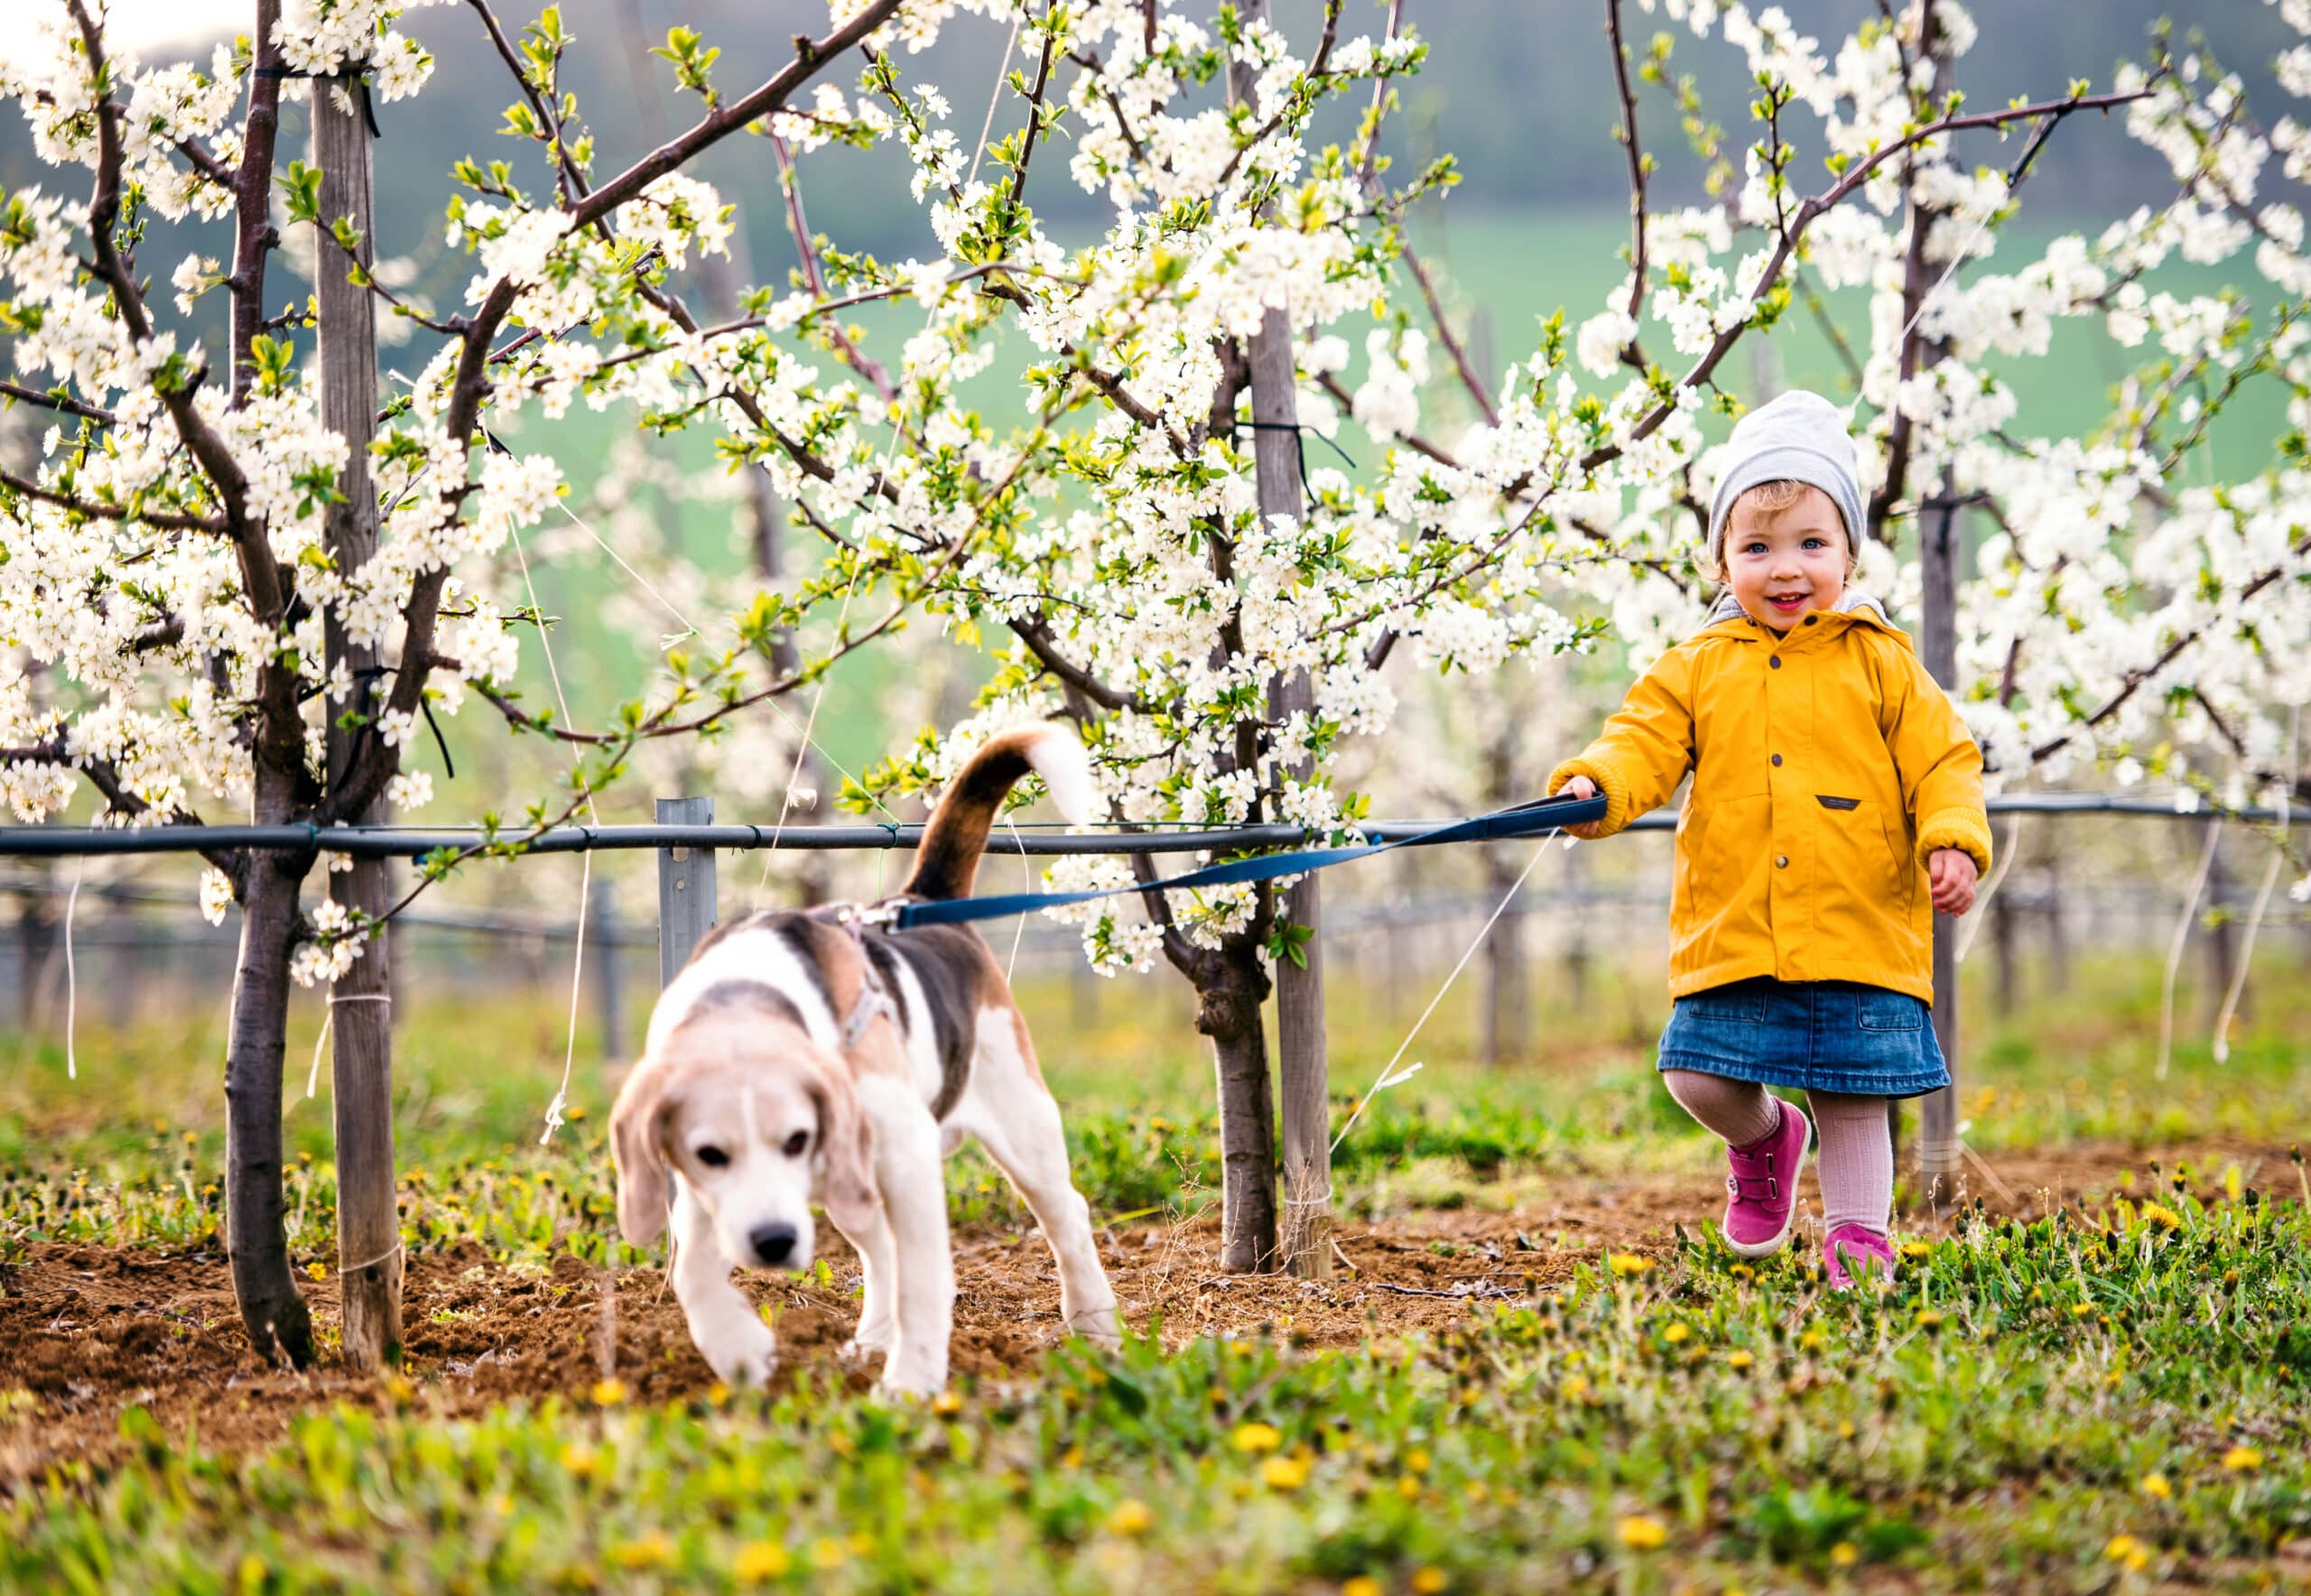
[1548,393,1990,1286]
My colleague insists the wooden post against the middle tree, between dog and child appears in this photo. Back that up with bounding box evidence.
[1230,0,1332,1279]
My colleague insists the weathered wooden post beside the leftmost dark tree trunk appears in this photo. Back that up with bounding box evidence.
[312,74,402,1369]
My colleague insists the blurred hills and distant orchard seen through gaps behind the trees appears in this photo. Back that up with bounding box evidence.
[0,0,2311,1157]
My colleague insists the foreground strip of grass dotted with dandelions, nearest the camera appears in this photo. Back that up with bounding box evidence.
[0,1192,2311,1591]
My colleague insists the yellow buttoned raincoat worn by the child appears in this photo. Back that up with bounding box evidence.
[1546,603,1990,1002]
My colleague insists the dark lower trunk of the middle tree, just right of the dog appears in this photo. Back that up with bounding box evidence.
[1195,938,1276,1275]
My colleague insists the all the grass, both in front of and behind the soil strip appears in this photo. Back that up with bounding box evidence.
[0,951,2311,1596]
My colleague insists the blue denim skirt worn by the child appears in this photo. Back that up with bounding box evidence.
[1659,975,1951,1097]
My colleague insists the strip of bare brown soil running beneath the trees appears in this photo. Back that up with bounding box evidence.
[0,1144,2295,1497]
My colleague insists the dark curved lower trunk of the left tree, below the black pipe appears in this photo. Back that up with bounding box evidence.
[224,836,312,1368]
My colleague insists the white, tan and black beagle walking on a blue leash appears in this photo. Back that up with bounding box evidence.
[610,725,1118,1395]
